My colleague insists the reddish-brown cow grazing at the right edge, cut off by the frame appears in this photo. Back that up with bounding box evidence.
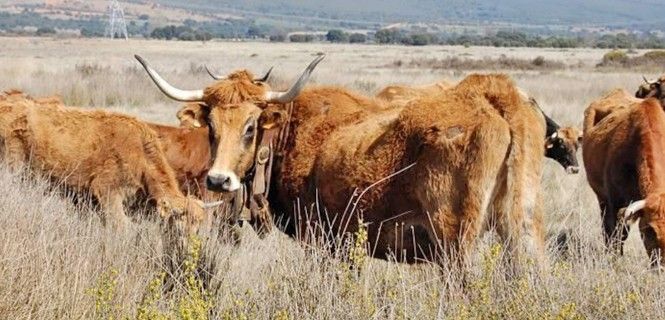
[583,99,665,263]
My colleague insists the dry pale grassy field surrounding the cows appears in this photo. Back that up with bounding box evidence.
[0,38,665,319]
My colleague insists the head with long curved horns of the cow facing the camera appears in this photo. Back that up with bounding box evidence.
[135,55,325,192]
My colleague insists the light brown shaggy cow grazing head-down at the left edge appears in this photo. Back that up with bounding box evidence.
[0,91,213,233]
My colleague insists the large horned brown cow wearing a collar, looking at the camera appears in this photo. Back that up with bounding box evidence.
[142,55,545,270]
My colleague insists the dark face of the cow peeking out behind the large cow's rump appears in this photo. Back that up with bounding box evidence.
[545,127,582,174]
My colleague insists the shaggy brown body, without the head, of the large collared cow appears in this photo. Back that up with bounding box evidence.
[275,76,544,261]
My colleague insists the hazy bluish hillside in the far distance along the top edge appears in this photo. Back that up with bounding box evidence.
[156,0,665,28]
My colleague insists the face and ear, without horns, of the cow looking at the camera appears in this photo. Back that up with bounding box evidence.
[206,102,285,192]
